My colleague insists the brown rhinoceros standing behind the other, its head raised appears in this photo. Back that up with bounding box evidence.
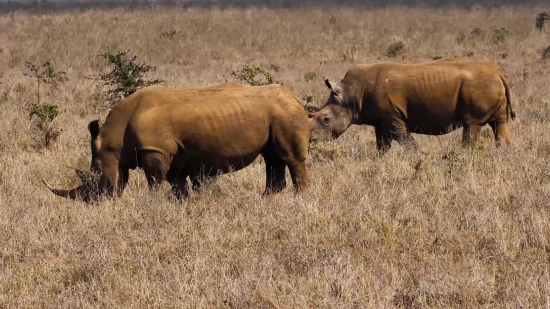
[309,58,515,152]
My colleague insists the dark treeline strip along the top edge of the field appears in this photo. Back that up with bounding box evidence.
[0,0,548,13]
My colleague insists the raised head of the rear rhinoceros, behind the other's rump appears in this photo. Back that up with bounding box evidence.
[309,79,354,141]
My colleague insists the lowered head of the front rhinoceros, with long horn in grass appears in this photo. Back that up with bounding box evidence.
[42,120,118,203]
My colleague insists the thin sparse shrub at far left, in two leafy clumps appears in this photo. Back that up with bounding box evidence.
[23,60,68,148]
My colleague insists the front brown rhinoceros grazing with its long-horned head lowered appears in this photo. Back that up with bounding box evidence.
[46,83,311,201]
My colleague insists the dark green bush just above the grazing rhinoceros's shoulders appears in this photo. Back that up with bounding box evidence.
[98,51,163,107]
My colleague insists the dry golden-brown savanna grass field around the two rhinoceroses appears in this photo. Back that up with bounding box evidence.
[0,1,550,308]
